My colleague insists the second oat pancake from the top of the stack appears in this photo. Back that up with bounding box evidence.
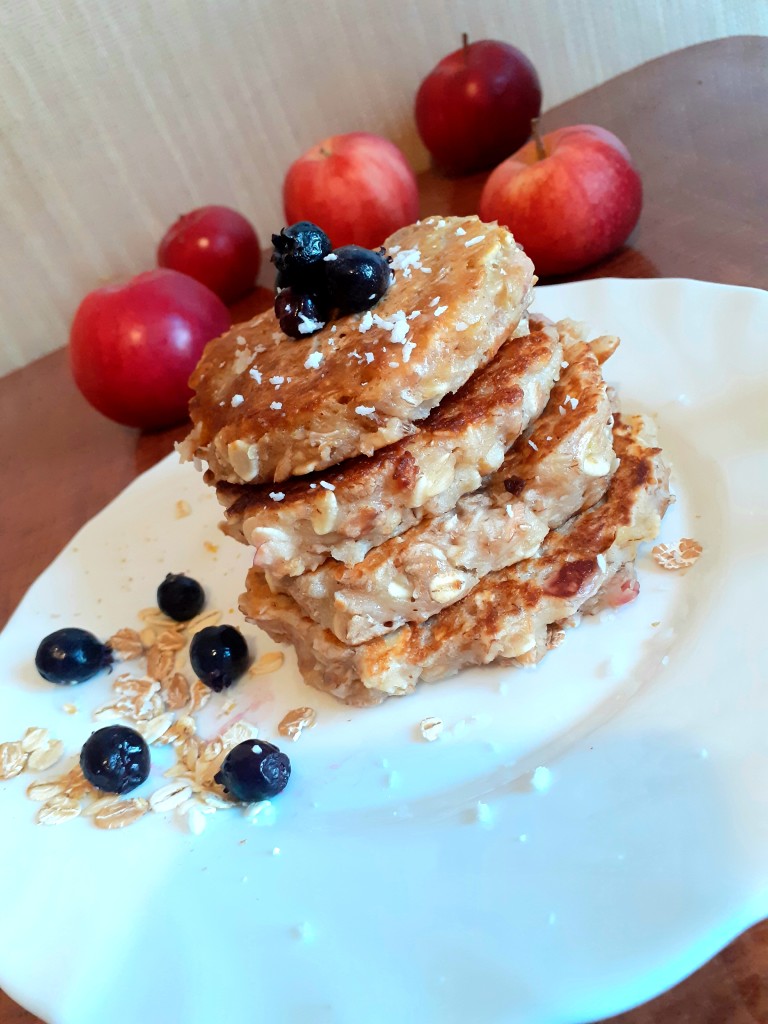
[217,317,562,577]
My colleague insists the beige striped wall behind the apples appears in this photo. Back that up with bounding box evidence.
[0,0,768,374]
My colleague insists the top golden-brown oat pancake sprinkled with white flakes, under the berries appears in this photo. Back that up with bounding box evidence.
[179,217,534,483]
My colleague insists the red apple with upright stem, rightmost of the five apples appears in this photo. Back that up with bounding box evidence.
[479,125,643,275]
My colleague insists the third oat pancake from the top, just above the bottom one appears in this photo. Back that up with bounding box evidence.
[266,331,616,644]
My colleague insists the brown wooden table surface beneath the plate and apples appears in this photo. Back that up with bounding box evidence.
[0,37,768,1024]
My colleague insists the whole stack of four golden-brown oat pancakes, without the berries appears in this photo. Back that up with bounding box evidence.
[181,217,670,705]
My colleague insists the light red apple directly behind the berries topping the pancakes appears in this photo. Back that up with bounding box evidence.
[283,131,419,249]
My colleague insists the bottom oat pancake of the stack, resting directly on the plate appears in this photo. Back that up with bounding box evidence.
[241,417,671,706]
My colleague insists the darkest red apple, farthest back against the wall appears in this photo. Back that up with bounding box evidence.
[416,36,542,174]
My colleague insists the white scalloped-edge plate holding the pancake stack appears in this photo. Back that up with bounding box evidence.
[0,280,768,1024]
